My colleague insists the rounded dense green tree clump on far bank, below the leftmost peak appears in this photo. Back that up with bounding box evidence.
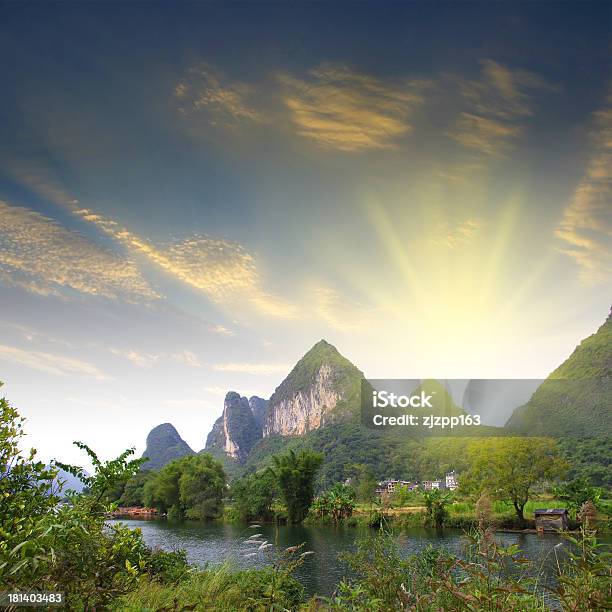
[143,454,225,519]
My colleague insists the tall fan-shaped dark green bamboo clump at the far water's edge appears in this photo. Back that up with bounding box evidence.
[270,449,323,523]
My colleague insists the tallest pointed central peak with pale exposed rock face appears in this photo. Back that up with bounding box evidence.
[263,340,363,436]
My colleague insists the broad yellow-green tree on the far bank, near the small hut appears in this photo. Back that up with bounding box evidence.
[461,438,567,523]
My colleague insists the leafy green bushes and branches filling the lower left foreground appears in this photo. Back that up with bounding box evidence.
[0,384,150,610]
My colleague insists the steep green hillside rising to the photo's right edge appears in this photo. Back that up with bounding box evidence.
[506,313,612,438]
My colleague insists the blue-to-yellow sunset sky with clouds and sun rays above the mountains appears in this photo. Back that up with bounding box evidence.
[0,2,612,462]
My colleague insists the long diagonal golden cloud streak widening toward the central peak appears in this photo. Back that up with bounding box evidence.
[75,209,297,318]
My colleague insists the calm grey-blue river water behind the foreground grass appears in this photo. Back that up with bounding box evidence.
[110,519,588,595]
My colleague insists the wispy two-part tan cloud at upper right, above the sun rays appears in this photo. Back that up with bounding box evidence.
[448,60,555,157]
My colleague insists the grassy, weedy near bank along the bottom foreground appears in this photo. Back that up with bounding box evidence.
[110,528,610,612]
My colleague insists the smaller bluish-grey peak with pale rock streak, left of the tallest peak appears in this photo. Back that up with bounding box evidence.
[204,391,267,463]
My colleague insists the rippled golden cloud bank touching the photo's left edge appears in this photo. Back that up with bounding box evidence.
[0,201,158,302]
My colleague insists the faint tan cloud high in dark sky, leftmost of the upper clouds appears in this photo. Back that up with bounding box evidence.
[174,64,265,127]
